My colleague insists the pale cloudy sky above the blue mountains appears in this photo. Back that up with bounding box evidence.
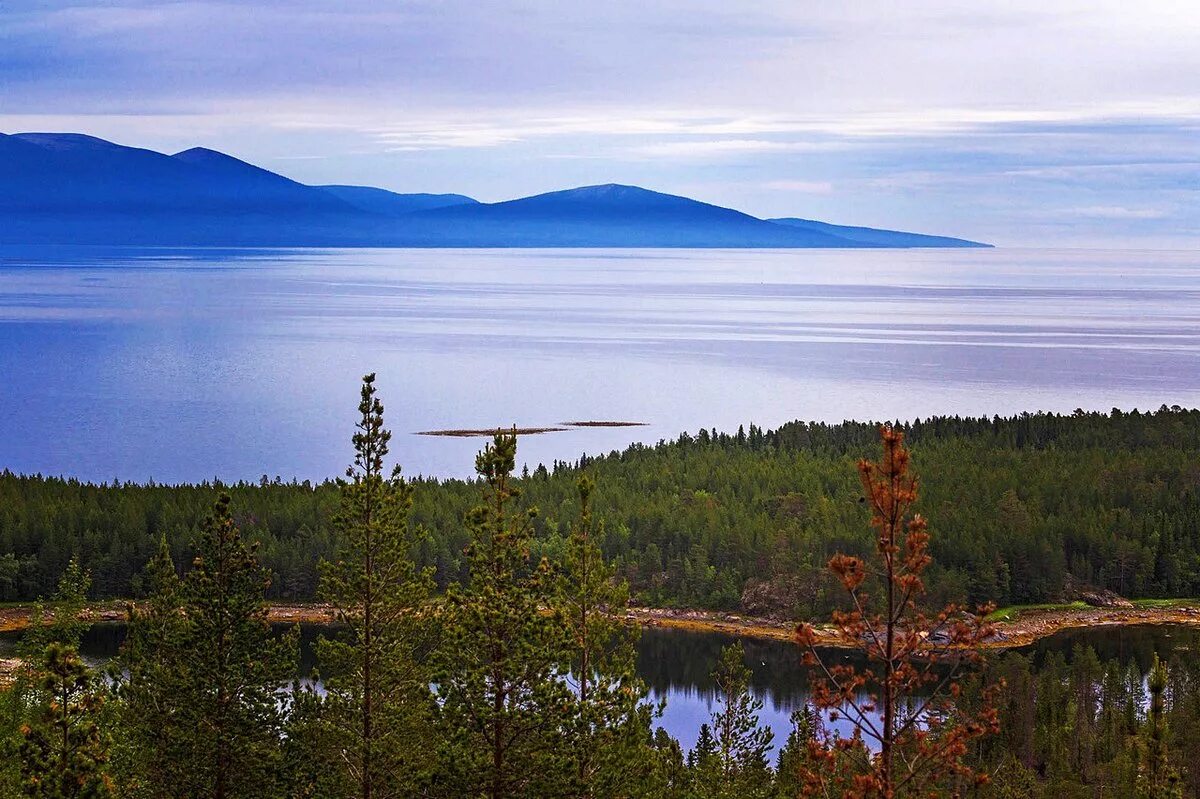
[0,0,1200,248]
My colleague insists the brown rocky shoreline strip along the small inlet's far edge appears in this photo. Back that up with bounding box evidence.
[0,600,1200,650]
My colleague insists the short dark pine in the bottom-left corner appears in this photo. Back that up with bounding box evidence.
[20,642,113,799]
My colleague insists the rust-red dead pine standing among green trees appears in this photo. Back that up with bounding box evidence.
[796,425,998,799]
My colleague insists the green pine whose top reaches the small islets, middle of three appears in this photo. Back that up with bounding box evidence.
[434,431,575,799]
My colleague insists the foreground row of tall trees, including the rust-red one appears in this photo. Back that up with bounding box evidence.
[0,376,1200,799]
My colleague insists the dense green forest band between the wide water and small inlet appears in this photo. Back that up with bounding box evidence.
[0,407,1200,609]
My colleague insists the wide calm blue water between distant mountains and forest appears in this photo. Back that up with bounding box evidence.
[0,247,1200,481]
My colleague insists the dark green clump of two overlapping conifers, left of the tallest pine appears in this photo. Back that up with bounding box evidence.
[122,497,298,799]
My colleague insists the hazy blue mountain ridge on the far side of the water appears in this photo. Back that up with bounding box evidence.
[0,133,988,248]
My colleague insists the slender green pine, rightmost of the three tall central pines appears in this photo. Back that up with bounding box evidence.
[556,476,655,798]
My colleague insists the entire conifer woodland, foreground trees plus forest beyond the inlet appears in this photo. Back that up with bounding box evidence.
[0,376,1200,799]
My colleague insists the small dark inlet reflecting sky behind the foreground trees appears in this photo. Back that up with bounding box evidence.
[0,624,1200,750]
